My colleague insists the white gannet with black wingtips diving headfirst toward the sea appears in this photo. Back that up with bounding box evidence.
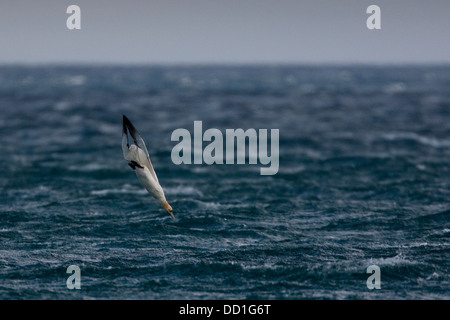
[122,115,175,219]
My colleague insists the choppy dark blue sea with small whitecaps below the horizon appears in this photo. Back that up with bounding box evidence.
[0,66,450,299]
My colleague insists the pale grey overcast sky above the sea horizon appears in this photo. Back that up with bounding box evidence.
[0,0,450,64]
